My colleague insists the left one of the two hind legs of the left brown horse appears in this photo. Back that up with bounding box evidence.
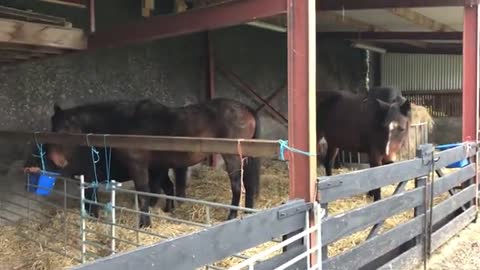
[222,155,242,220]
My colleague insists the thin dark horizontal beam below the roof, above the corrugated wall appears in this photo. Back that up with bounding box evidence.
[317,32,463,40]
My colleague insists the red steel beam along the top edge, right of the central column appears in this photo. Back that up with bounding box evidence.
[317,0,478,10]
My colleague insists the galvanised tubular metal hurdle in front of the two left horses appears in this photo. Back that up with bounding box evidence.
[0,171,281,269]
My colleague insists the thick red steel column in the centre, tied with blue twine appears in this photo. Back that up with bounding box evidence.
[287,0,317,201]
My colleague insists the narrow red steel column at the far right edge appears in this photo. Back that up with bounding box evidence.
[462,5,479,141]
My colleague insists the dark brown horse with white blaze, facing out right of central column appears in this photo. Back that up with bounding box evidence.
[317,91,411,200]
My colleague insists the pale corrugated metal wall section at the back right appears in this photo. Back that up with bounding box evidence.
[381,53,462,91]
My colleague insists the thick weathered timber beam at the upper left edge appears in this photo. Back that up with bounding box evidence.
[0,19,86,50]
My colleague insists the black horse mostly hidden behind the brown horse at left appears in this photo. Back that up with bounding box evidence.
[25,100,187,220]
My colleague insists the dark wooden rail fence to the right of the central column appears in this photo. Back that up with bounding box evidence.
[317,141,477,270]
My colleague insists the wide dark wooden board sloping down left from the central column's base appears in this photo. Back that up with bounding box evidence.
[70,200,311,270]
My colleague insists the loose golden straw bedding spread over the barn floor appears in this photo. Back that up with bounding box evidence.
[0,161,454,270]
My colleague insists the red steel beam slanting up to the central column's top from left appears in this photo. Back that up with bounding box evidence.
[88,0,287,49]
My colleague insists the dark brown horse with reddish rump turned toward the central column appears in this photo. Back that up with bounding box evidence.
[48,98,260,226]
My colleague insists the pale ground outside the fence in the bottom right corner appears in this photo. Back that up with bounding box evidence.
[417,221,480,270]
